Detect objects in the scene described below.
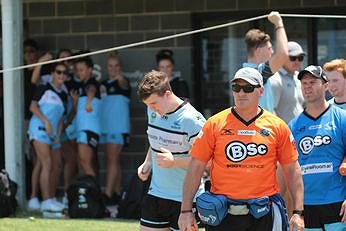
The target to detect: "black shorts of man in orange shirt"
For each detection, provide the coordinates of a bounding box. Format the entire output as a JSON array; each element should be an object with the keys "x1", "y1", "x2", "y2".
[{"x1": 205, "y1": 209, "x2": 273, "y2": 231}]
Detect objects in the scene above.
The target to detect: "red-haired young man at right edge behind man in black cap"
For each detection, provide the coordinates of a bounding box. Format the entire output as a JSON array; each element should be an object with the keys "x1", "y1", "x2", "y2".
[{"x1": 323, "y1": 59, "x2": 346, "y2": 110}]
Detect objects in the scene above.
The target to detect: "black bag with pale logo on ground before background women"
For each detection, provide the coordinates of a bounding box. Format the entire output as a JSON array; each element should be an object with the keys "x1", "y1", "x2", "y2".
[{"x1": 67, "y1": 175, "x2": 107, "y2": 218}]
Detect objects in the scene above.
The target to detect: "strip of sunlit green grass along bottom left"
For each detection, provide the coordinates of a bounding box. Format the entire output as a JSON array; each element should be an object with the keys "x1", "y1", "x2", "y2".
[{"x1": 0, "y1": 211, "x2": 139, "y2": 231}]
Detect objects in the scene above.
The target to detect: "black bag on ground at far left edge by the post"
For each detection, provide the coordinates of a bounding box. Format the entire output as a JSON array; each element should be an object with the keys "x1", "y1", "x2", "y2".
[{"x1": 0, "y1": 169, "x2": 17, "y2": 217}]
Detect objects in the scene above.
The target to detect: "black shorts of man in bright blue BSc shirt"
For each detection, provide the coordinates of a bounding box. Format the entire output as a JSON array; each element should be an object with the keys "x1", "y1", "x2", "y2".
[{"x1": 304, "y1": 202, "x2": 342, "y2": 228}]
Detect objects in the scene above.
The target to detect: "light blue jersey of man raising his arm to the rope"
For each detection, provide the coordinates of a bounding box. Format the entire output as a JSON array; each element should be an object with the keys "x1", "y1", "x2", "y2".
[{"x1": 243, "y1": 62, "x2": 274, "y2": 113}]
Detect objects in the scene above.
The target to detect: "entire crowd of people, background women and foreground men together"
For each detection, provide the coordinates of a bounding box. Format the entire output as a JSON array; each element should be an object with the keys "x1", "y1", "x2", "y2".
[{"x1": 0, "y1": 9, "x2": 346, "y2": 231}]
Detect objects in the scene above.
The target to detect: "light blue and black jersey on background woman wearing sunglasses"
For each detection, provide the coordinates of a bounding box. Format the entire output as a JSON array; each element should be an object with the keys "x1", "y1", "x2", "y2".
[{"x1": 28, "y1": 82, "x2": 67, "y2": 137}]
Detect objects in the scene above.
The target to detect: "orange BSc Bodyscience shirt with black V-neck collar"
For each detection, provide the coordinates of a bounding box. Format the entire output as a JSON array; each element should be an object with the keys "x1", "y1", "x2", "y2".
[{"x1": 190, "y1": 108, "x2": 298, "y2": 199}]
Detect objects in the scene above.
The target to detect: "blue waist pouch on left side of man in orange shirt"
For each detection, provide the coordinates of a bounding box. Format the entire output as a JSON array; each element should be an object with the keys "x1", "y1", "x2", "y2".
[{"x1": 196, "y1": 191, "x2": 228, "y2": 226}]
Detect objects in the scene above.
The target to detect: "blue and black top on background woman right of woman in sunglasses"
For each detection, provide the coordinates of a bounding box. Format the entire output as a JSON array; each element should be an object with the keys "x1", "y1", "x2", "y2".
[{"x1": 76, "y1": 78, "x2": 101, "y2": 135}]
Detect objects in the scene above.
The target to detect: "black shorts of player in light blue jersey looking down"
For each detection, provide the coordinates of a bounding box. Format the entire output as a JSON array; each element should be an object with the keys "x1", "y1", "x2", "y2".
[{"x1": 140, "y1": 194, "x2": 199, "y2": 230}]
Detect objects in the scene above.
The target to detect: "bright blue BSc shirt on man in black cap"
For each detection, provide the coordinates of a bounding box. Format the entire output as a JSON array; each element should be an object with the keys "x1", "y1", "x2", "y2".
[{"x1": 289, "y1": 105, "x2": 346, "y2": 205}]
